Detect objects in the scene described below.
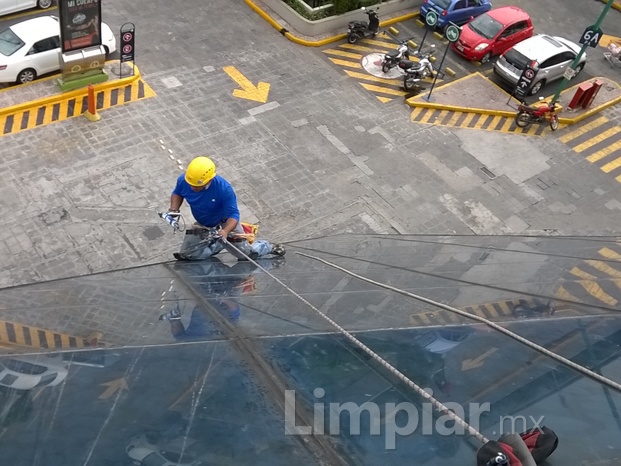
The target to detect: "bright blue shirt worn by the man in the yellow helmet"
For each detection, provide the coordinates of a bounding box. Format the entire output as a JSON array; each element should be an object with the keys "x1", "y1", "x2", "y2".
[{"x1": 172, "y1": 175, "x2": 239, "y2": 227}]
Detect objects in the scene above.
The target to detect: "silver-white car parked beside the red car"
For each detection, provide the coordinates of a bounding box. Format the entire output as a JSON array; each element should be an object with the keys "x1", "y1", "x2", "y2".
[{"x1": 494, "y1": 34, "x2": 586, "y2": 95}]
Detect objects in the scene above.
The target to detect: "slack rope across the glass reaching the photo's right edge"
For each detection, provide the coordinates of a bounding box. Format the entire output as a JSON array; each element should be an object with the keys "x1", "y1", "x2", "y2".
[{"x1": 294, "y1": 251, "x2": 621, "y2": 392}]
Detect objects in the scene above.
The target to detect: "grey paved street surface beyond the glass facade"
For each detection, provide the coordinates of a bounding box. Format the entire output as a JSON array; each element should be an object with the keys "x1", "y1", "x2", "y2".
[{"x1": 0, "y1": 0, "x2": 621, "y2": 292}]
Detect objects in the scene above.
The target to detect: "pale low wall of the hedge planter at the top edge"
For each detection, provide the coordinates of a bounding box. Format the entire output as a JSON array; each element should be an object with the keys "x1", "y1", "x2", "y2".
[{"x1": 263, "y1": 0, "x2": 423, "y2": 36}]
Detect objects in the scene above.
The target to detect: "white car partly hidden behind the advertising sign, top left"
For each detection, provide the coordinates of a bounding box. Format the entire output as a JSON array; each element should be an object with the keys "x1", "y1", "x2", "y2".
[{"x1": 0, "y1": 16, "x2": 116, "y2": 84}]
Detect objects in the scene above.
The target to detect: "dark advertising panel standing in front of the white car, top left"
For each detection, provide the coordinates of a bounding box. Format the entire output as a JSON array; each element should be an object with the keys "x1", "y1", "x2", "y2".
[{"x1": 58, "y1": 0, "x2": 101, "y2": 53}]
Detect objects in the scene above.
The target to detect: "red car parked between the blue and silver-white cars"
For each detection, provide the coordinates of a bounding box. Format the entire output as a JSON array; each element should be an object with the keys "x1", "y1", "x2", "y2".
[{"x1": 451, "y1": 6, "x2": 534, "y2": 63}]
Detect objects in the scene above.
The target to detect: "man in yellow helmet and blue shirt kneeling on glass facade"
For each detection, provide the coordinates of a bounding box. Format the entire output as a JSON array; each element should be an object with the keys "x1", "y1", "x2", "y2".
[{"x1": 168, "y1": 157, "x2": 285, "y2": 260}]
